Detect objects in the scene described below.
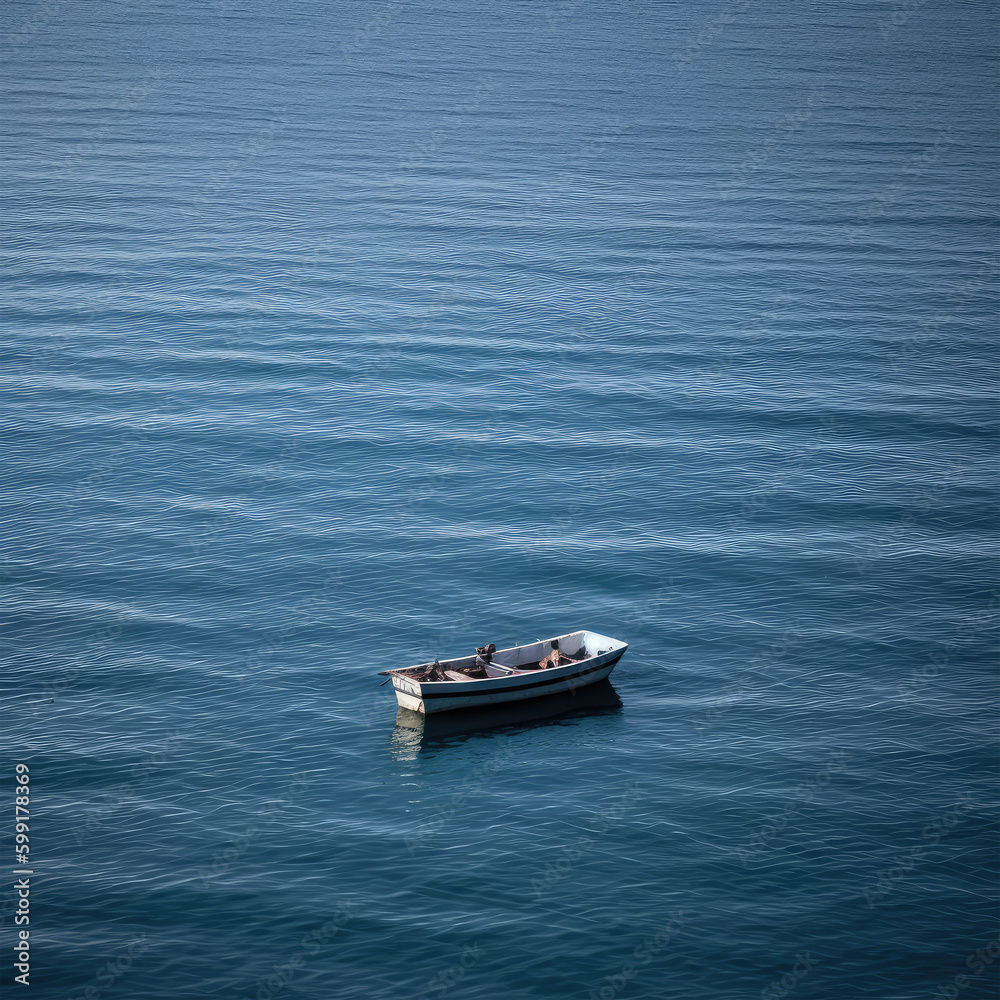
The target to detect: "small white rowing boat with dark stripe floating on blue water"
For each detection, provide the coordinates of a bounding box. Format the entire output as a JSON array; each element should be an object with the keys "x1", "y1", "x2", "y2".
[{"x1": 381, "y1": 631, "x2": 628, "y2": 715}]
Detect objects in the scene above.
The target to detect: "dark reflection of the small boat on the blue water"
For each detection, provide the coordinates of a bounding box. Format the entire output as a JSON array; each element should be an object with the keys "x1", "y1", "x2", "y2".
[{"x1": 392, "y1": 681, "x2": 622, "y2": 757}]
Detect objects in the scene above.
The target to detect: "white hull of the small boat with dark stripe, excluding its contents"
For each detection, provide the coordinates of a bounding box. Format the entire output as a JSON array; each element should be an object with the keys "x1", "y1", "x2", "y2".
[{"x1": 391, "y1": 631, "x2": 628, "y2": 715}]
